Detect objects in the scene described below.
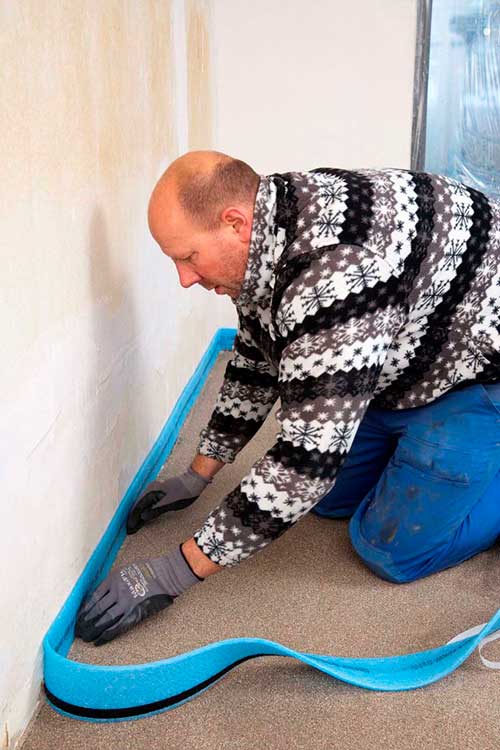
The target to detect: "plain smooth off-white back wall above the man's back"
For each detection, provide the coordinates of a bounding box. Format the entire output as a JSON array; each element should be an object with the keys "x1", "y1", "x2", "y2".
[{"x1": 209, "y1": 0, "x2": 417, "y2": 173}]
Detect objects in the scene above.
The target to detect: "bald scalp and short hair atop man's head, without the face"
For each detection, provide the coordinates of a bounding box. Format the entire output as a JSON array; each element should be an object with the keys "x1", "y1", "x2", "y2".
[{"x1": 149, "y1": 151, "x2": 260, "y2": 231}]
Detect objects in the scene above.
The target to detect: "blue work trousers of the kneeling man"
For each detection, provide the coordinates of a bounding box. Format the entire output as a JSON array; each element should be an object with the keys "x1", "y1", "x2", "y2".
[{"x1": 311, "y1": 384, "x2": 500, "y2": 583}]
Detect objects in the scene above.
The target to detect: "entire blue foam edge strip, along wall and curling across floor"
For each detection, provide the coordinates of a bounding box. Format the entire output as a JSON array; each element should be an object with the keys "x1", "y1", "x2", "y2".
[{"x1": 43, "y1": 329, "x2": 500, "y2": 722}]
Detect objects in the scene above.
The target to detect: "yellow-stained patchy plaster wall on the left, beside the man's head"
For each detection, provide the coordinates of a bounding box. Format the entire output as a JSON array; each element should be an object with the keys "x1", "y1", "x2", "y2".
[{"x1": 0, "y1": 0, "x2": 235, "y2": 747}]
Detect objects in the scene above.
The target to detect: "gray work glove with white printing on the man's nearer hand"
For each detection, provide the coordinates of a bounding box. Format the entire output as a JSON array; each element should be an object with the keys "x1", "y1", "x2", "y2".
[{"x1": 75, "y1": 544, "x2": 205, "y2": 646}]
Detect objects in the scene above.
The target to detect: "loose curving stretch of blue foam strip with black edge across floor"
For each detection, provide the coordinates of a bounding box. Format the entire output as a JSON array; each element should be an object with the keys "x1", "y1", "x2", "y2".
[{"x1": 44, "y1": 610, "x2": 500, "y2": 721}]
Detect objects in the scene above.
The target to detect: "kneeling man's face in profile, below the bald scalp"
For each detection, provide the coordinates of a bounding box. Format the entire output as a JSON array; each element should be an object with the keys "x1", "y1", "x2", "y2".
[{"x1": 148, "y1": 187, "x2": 252, "y2": 299}]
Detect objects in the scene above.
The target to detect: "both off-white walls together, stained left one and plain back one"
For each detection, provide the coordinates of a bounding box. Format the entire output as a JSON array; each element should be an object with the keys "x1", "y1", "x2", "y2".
[{"x1": 0, "y1": 0, "x2": 416, "y2": 747}]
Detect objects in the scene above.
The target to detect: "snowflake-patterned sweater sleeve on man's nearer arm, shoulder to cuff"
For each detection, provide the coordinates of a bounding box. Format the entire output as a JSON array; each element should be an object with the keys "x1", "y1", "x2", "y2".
[{"x1": 194, "y1": 245, "x2": 402, "y2": 566}]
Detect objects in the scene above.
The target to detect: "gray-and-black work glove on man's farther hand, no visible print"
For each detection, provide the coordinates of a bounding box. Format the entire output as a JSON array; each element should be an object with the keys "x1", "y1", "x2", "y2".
[{"x1": 127, "y1": 468, "x2": 212, "y2": 534}]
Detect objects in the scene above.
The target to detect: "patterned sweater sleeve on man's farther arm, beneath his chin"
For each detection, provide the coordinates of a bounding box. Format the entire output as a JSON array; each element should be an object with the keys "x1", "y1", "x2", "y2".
[{"x1": 198, "y1": 317, "x2": 278, "y2": 463}]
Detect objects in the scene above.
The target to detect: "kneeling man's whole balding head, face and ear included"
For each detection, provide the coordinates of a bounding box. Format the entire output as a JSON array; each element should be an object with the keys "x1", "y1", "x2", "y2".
[{"x1": 148, "y1": 151, "x2": 260, "y2": 299}]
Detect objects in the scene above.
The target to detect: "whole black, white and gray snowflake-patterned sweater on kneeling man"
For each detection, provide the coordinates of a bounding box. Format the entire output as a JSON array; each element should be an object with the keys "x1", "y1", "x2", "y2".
[{"x1": 194, "y1": 168, "x2": 500, "y2": 566}]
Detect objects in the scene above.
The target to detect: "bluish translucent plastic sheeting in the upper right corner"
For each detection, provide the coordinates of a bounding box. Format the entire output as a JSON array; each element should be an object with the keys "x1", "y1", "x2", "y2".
[{"x1": 425, "y1": 0, "x2": 500, "y2": 199}]
